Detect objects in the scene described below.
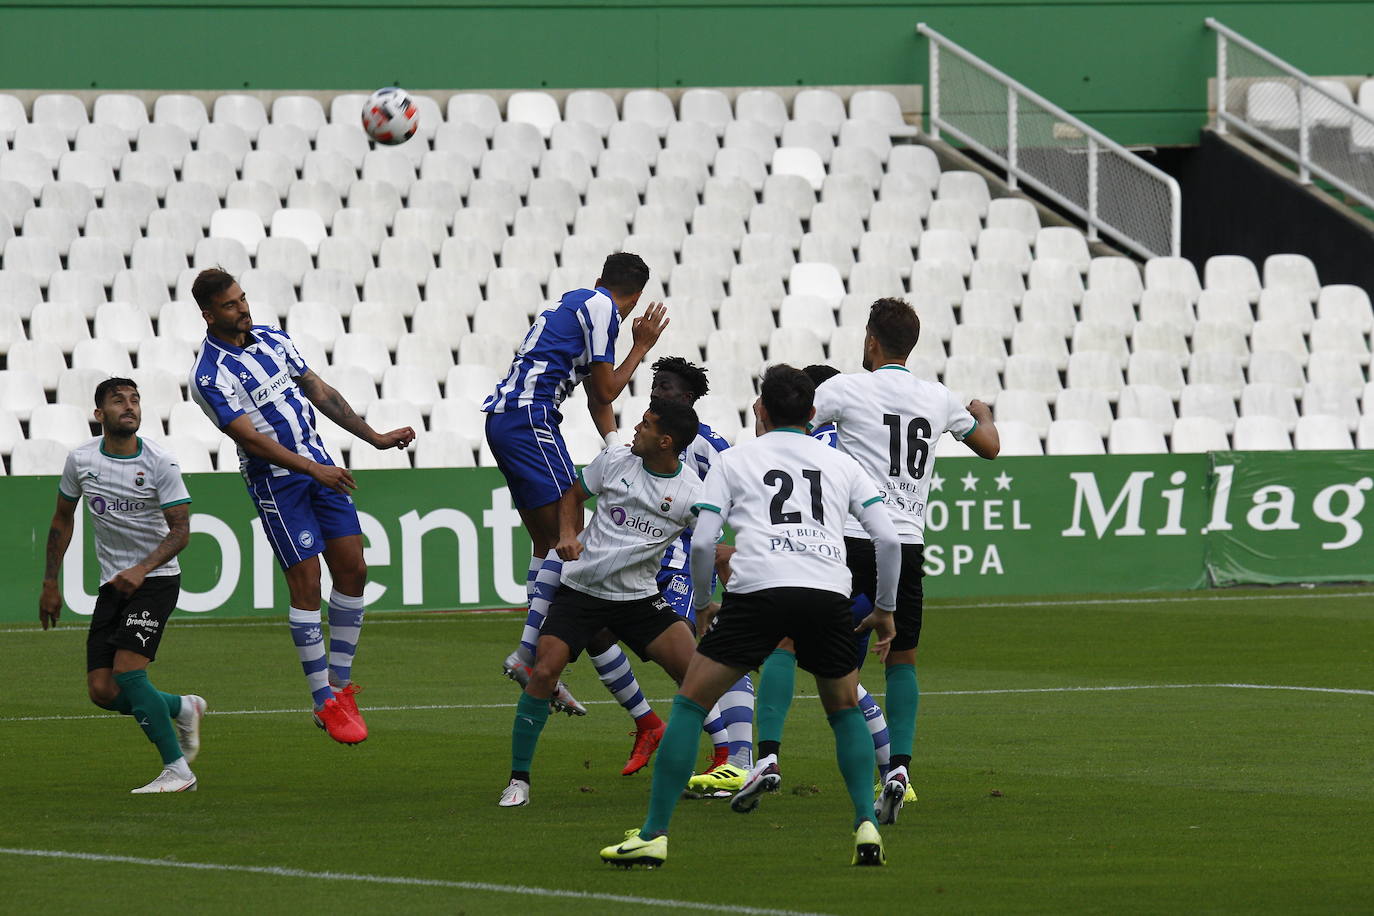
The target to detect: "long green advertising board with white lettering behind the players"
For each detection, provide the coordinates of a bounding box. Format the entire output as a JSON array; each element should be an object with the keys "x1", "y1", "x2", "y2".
[{"x1": 0, "y1": 450, "x2": 1374, "y2": 621}]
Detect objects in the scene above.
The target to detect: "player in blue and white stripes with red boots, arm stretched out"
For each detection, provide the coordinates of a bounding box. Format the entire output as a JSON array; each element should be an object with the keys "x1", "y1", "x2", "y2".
[{"x1": 190, "y1": 268, "x2": 415, "y2": 744}]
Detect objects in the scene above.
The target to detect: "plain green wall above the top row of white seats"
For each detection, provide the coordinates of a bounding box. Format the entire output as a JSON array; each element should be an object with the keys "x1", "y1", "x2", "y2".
[{"x1": 0, "y1": 0, "x2": 1374, "y2": 144}]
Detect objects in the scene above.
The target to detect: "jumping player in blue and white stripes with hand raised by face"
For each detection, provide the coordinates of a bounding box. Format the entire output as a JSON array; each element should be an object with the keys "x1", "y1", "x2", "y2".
[{"x1": 482, "y1": 251, "x2": 668, "y2": 715}]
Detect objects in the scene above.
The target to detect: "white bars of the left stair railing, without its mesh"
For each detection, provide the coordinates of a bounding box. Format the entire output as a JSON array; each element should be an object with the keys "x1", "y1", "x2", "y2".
[{"x1": 916, "y1": 22, "x2": 1183, "y2": 258}]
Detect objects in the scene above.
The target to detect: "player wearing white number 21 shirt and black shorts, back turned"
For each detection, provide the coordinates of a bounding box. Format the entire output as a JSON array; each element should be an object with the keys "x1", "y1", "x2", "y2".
[{"x1": 600, "y1": 365, "x2": 901, "y2": 867}]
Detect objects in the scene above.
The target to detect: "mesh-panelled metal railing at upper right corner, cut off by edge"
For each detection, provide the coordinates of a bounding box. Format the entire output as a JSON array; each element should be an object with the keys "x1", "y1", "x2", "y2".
[{"x1": 1204, "y1": 16, "x2": 1374, "y2": 207}]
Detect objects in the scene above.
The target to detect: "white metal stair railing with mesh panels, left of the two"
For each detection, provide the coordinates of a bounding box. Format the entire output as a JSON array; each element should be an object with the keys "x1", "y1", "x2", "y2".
[{"x1": 916, "y1": 22, "x2": 1183, "y2": 258}]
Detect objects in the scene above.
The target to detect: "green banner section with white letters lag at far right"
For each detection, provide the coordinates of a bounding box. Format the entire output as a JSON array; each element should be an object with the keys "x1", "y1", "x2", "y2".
[{"x1": 1206, "y1": 450, "x2": 1374, "y2": 585}]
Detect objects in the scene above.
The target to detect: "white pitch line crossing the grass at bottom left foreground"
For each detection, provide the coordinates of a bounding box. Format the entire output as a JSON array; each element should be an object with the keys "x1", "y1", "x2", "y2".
[{"x1": 0, "y1": 846, "x2": 822, "y2": 916}]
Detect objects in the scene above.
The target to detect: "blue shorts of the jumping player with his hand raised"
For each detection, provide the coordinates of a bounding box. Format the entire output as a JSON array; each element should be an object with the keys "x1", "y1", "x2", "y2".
[{"x1": 486, "y1": 404, "x2": 577, "y2": 509}]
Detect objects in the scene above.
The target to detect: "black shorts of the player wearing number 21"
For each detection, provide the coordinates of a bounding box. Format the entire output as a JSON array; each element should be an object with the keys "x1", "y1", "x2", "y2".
[{"x1": 697, "y1": 588, "x2": 856, "y2": 677}]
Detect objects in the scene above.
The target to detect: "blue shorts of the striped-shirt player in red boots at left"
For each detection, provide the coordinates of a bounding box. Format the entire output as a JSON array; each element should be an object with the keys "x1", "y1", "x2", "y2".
[{"x1": 249, "y1": 474, "x2": 363, "y2": 570}]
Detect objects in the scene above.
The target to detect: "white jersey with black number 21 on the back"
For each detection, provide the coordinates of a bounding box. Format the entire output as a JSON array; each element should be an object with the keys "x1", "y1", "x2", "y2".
[{"x1": 697, "y1": 428, "x2": 882, "y2": 596}]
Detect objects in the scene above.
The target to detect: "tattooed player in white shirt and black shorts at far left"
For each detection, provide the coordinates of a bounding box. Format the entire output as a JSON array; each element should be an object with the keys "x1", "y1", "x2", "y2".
[{"x1": 38, "y1": 378, "x2": 205, "y2": 795}]
